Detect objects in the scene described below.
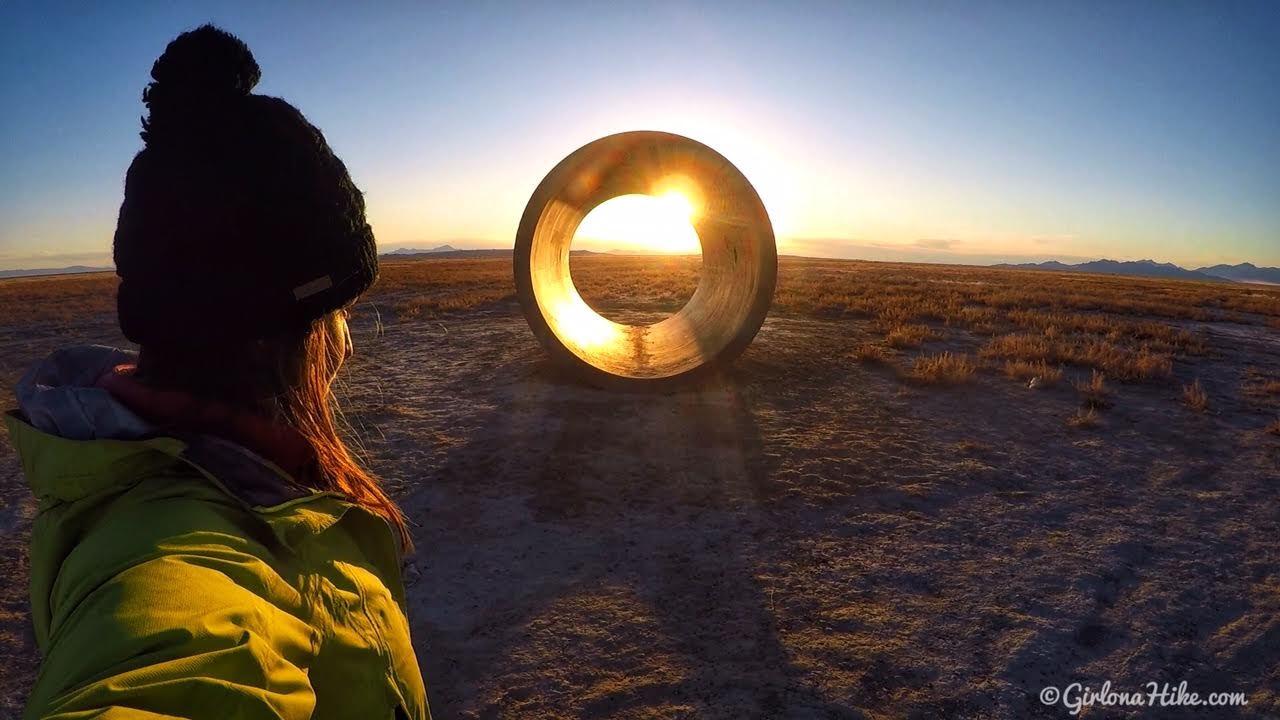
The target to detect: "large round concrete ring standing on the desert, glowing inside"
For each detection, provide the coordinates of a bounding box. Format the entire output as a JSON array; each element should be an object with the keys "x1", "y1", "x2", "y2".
[{"x1": 515, "y1": 131, "x2": 778, "y2": 389}]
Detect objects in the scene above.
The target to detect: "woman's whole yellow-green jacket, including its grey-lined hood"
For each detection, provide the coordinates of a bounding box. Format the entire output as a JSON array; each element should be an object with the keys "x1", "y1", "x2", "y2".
[{"x1": 5, "y1": 346, "x2": 430, "y2": 719}]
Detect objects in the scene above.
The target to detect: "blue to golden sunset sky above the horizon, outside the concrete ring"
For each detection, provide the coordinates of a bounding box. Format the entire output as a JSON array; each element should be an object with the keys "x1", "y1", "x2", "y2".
[{"x1": 0, "y1": 0, "x2": 1280, "y2": 269}]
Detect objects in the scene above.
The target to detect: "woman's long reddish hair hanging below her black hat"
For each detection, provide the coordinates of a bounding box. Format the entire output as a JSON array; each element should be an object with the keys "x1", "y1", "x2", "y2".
[{"x1": 138, "y1": 305, "x2": 412, "y2": 551}]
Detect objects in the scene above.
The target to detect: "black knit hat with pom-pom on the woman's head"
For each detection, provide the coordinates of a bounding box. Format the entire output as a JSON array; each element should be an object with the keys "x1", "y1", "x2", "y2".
[{"x1": 114, "y1": 26, "x2": 378, "y2": 346}]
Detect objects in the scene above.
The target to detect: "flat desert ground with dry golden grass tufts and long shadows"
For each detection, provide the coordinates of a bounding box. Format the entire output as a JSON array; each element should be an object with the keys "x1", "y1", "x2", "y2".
[{"x1": 0, "y1": 256, "x2": 1280, "y2": 719}]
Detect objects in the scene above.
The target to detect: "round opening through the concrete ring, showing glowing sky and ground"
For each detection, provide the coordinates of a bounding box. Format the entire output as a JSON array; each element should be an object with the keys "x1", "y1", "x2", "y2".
[{"x1": 570, "y1": 192, "x2": 703, "y2": 325}]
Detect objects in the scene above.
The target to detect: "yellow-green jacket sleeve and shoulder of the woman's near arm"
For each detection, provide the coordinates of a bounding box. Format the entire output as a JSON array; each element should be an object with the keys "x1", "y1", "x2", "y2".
[{"x1": 28, "y1": 478, "x2": 316, "y2": 717}]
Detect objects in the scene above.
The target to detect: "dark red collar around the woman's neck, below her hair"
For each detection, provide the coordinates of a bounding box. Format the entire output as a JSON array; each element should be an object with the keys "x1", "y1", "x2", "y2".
[{"x1": 95, "y1": 364, "x2": 316, "y2": 484}]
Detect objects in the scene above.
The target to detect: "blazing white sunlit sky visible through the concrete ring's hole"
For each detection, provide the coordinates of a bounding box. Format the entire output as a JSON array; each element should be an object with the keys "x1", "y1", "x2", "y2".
[{"x1": 573, "y1": 190, "x2": 701, "y2": 255}]
